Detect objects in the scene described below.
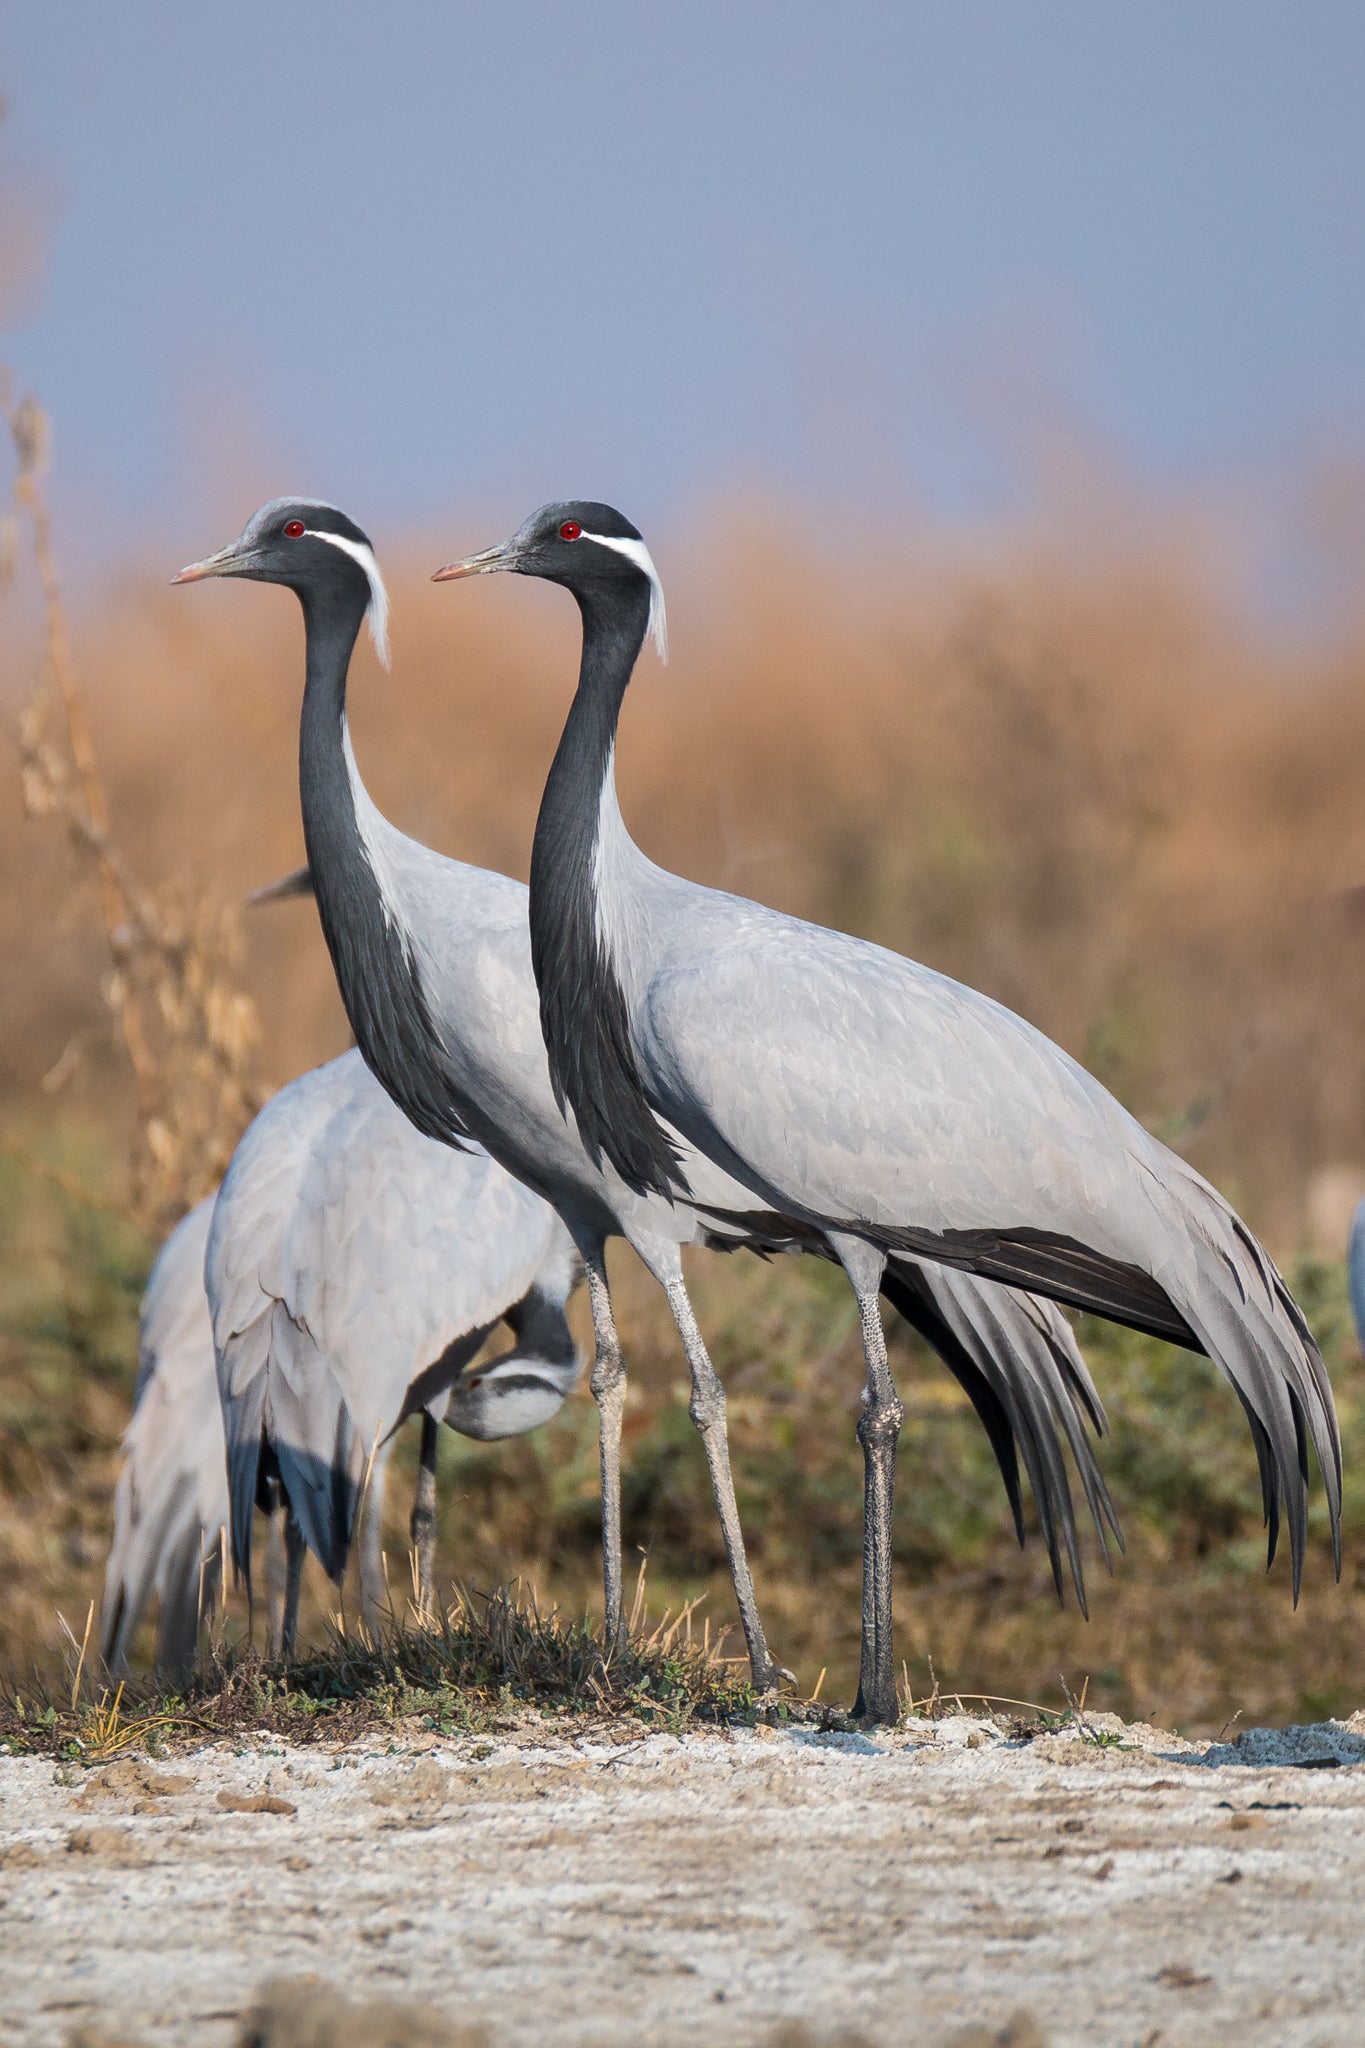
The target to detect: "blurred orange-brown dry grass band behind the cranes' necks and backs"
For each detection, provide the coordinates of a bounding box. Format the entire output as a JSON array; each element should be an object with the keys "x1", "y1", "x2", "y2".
[{"x1": 0, "y1": 471, "x2": 1365, "y2": 1249}]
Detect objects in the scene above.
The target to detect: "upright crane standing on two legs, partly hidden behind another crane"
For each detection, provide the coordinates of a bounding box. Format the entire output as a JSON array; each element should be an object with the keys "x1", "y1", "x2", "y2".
[{"x1": 176, "y1": 498, "x2": 1117, "y2": 1690}]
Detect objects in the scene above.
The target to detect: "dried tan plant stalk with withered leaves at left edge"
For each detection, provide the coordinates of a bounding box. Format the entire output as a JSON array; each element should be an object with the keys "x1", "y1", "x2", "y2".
[{"x1": 0, "y1": 377, "x2": 264, "y2": 1231}]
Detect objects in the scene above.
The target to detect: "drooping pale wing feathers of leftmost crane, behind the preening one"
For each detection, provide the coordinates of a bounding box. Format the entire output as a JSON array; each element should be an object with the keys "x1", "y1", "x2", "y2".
[{"x1": 100, "y1": 1196, "x2": 227, "y2": 1669}]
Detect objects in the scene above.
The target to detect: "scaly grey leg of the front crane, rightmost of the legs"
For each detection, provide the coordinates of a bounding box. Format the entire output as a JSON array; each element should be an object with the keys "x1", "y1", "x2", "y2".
[{"x1": 835, "y1": 1239, "x2": 905, "y2": 1729}]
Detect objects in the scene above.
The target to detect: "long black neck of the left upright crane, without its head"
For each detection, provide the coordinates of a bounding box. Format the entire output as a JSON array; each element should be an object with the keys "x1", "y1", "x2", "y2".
[{"x1": 299, "y1": 592, "x2": 469, "y2": 1145}]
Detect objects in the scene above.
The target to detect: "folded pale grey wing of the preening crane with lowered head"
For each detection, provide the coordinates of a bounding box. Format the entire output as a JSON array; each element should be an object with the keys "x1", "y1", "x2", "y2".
[{"x1": 207, "y1": 1053, "x2": 559, "y2": 1575}]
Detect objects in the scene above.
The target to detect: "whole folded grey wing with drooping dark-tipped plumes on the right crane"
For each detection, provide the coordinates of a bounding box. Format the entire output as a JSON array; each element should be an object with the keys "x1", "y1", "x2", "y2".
[{"x1": 632, "y1": 885, "x2": 1340, "y2": 1589}]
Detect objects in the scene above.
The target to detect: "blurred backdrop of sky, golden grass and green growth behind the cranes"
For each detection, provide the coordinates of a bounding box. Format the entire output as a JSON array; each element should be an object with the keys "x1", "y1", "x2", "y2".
[{"x1": 0, "y1": 0, "x2": 1365, "y2": 1726}]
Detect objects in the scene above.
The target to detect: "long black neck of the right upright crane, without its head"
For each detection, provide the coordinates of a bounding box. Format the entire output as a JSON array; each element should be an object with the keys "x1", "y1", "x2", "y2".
[{"x1": 530, "y1": 578, "x2": 688, "y2": 1198}]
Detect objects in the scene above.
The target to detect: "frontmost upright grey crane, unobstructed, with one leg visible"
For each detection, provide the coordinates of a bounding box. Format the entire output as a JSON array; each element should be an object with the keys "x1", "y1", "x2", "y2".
[{"x1": 436, "y1": 502, "x2": 1340, "y2": 1720}]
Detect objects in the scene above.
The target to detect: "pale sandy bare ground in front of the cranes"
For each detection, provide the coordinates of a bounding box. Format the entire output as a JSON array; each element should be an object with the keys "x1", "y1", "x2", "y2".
[{"x1": 0, "y1": 1716, "x2": 1365, "y2": 2048}]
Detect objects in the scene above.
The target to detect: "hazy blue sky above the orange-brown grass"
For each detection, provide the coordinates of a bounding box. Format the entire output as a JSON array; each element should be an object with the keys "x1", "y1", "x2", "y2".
[{"x1": 0, "y1": 0, "x2": 1365, "y2": 593}]
